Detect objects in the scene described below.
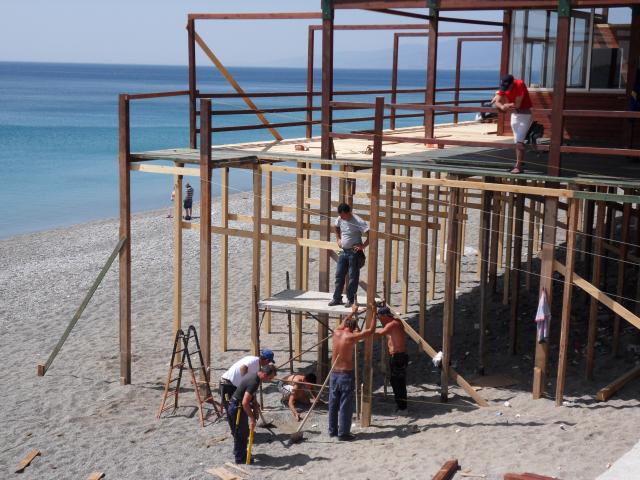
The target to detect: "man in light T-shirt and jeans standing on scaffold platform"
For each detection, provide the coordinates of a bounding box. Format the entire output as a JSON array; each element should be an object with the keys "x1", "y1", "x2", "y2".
[{"x1": 329, "y1": 203, "x2": 369, "y2": 308}]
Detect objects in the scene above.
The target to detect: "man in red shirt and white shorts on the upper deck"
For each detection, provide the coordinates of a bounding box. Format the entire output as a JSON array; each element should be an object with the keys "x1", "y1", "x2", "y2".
[{"x1": 494, "y1": 74, "x2": 532, "y2": 173}]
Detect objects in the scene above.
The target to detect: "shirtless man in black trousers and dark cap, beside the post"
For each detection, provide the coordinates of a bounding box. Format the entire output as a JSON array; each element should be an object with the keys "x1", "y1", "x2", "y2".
[{"x1": 376, "y1": 306, "x2": 409, "y2": 413}]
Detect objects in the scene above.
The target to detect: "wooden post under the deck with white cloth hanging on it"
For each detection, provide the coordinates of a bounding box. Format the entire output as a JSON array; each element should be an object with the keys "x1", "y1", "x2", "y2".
[{"x1": 533, "y1": 197, "x2": 558, "y2": 399}]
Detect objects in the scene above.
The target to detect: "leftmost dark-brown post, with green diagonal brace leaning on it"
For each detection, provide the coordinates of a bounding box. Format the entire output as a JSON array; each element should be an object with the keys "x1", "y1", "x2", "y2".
[{"x1": 118, "y1": 95, "x2": 131, "y2": 385}]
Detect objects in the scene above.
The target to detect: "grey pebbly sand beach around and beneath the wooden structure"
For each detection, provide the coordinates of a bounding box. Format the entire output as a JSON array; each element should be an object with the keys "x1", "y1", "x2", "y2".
[{"x1": 0, "y1": 181, "x2": 640, "y2": 480}]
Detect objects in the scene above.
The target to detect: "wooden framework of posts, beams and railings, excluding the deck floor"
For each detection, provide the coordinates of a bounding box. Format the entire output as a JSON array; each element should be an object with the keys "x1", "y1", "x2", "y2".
[{"x1": 119, "y1": 0, "x2": 640, "y2": 432}]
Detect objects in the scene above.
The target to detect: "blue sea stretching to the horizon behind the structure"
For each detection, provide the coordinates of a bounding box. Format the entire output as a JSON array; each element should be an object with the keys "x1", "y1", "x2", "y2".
[{"x1": 0, "y1": 62, "x2": 499, "y2": 238}]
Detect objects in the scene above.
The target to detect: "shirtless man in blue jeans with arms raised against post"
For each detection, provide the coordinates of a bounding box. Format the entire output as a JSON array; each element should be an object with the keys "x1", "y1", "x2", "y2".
[{"x1": 329, "y1": 305, "x2": 376, "y2": 440}]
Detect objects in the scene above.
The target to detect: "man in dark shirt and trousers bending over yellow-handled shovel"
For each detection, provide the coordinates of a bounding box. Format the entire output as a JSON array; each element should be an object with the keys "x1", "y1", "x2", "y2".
[{"x1": 227, "y1": 365, "x2": 277, "y2": 463}]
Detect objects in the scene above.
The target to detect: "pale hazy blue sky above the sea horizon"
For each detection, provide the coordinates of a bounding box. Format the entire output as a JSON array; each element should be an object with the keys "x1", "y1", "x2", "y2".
[{"x1": 0, "y1": 0, "x2": 501, "y2": 68}]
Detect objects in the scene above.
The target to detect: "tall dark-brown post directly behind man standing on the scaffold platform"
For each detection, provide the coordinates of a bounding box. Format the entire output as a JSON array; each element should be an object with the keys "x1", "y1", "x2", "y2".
[{"x1": 317, "y1": 0, "x2": 334, "y2": 380}]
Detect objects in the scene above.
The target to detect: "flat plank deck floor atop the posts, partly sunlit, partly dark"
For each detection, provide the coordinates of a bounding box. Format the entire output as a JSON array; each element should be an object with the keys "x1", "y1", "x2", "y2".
[{"x1": 131, "y1": 122, "x2": 640, "y2": 188}]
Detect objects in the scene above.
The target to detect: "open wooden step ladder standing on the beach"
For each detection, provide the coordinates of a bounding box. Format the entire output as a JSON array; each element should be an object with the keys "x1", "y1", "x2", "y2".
[{"x1": 156, "y1": 325, "x2": 222, "y2": 427}]
